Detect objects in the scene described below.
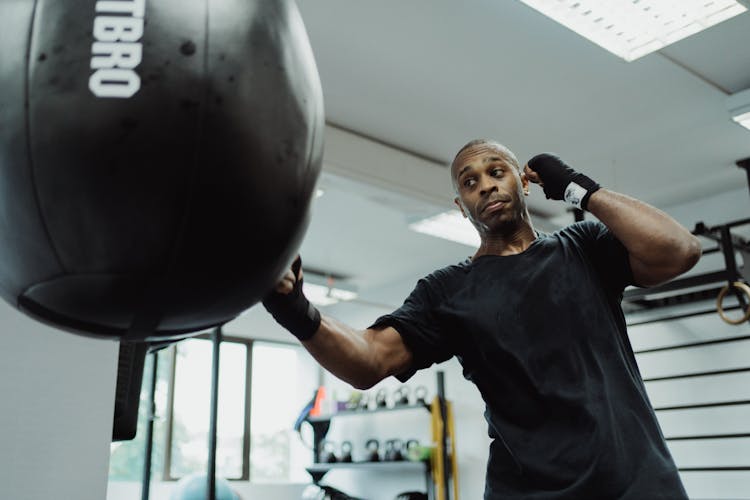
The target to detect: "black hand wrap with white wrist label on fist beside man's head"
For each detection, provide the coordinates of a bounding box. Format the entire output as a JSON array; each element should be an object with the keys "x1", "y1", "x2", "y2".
[{"x1": 527, "y1": 153, "x2": 601, "y2": 210}]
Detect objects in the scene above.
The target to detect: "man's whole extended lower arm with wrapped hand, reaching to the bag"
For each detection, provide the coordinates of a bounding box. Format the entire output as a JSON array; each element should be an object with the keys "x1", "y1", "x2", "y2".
[{"x1": 263, "y1": 258, "x2": 412, "y2": 389}]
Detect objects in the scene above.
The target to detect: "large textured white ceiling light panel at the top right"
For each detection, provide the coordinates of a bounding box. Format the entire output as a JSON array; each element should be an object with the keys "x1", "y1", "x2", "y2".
[{"x1": 521, "y1": 0, "x2": 747, "y2": 61}]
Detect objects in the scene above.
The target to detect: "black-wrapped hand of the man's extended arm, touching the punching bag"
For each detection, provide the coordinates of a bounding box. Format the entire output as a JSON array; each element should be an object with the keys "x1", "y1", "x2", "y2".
[{"x1": 263, "y1": 257, "x2": 320, "y2": 340}]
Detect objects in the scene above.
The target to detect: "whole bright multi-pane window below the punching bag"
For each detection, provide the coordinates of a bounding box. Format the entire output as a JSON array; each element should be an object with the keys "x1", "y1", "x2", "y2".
[{"x1": 109, "y1": 335, "x2": 320, "y2": 490}]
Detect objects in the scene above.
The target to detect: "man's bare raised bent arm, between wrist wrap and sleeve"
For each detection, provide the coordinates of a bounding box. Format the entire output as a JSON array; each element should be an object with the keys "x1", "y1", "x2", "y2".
[{"x1": 586, "y1": 188, "x2": 701, "y2": 286}]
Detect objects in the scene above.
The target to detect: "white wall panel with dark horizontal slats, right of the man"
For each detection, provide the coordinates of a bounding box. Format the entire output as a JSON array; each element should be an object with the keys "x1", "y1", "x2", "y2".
[{"x1": 628, "y1": 304, "x2": 750, "y2": 500}]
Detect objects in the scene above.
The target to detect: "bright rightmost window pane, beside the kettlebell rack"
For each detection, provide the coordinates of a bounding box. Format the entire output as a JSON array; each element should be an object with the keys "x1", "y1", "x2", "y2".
[{"x1": 250, "y1": 342, "x2": 319, "y2": 482}]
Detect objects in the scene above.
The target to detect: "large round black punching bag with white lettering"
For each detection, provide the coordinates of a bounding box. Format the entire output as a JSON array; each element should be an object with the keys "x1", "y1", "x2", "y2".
[{"x1": 0, "y1": 0, "x2": 324, "y2": 340}]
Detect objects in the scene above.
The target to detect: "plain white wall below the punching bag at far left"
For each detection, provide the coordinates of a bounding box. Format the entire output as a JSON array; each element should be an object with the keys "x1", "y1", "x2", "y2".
[{"x1": 0, "y1": 301, "x2": 118, "y2": 500}]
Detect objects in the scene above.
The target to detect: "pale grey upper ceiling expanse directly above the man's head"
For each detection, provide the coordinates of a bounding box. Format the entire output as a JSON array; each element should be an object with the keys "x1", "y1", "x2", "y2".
[{"x1": 299, "y1": 0, "x2": 750, "y2": 203}]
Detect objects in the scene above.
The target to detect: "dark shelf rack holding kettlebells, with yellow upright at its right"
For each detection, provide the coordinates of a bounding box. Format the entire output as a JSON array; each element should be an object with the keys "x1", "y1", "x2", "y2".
[{"x1": 306, "y1": 372, "x2": 458, "y2": 500}]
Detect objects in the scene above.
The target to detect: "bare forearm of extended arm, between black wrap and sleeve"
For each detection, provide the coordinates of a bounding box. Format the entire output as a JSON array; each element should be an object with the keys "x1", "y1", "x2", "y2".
[{"x1": 302, "y1": 315, "x2": 388, "y2": 389}]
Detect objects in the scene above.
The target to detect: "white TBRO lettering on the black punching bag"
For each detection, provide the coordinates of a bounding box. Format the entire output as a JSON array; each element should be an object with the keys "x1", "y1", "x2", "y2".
[{"x1": 89, "y1": 0, "x2": 146, "y2": 99}]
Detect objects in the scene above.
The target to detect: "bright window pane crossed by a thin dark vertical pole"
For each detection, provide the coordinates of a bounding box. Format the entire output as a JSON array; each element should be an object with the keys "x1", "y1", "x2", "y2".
[{"x1": 170, "y1": 339, "x2": 247, "y2": 479}]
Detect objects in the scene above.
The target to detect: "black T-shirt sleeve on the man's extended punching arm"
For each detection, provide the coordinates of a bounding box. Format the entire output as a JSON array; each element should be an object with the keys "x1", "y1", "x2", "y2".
[{"x1": 370, "y1": 275, "x2": 453, "y2": 382}]
